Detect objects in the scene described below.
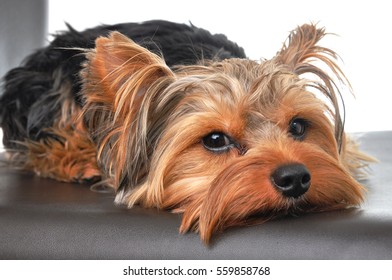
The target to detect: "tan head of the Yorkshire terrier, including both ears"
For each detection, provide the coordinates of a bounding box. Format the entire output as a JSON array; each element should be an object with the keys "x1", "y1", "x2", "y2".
[{"x1": 82, "y1": 25, "x2": 363, "y2": 242}]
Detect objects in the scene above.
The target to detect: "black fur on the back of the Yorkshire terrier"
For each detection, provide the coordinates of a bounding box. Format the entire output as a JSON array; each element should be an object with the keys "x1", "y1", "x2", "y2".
[{"x1": 0, "y1": 20, "x2": 245, "y2": 148}]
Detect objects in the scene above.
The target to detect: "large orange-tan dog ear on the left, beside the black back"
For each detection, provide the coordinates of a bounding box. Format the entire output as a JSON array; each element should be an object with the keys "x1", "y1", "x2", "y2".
[{"x1": 81, "y1": 32, "x2": 174, "y2": 190}]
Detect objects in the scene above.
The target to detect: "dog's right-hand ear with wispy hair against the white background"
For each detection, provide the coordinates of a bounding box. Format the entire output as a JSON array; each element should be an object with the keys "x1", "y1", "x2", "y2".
[{"x1": 275, "y1": 24, "x2": 351, "y2": 147}]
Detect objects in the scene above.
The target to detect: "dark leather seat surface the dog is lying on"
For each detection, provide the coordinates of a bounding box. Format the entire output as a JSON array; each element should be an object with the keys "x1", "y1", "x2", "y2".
[{"x1": 0, "y1": 131, "x2": 392, "y2": 259}]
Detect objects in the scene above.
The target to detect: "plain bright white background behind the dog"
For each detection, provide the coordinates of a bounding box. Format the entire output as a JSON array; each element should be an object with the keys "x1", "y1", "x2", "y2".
[{"x1": 40, "y1": 0, "x2": 392, "y2": 132}]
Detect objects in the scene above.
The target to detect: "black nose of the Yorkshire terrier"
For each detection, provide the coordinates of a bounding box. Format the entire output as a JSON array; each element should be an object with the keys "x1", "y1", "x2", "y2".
[{"x1": 271, "y1": 163, "x2": 310, "y2": 198}]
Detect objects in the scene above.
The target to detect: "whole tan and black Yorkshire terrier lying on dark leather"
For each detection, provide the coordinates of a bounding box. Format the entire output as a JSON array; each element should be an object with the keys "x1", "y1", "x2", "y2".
[{"x1": 0, "y1": 21, "x2": 371, "y2": 243}]
